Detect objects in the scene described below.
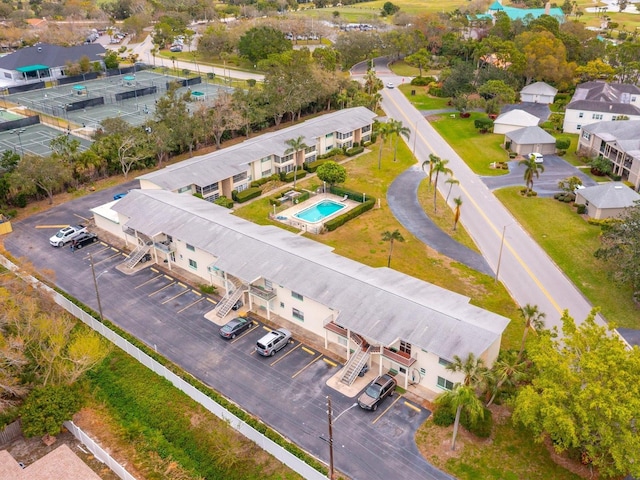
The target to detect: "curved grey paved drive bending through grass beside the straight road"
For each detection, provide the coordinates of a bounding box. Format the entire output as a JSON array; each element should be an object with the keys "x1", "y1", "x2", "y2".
[{"x1": 387, "y1": 165, "x2": 493, "y2": 275}]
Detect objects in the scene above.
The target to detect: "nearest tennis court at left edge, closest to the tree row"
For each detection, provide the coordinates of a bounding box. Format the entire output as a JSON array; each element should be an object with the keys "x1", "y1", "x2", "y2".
[{"x1": 0, "y1": 124, "x2": 91, "y2": 156}]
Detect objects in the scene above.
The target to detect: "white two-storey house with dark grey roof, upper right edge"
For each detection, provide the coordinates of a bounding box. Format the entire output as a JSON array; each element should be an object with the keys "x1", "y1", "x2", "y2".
[{"x1": 562, "y1": 81, "x2": 640, "y2": 133}]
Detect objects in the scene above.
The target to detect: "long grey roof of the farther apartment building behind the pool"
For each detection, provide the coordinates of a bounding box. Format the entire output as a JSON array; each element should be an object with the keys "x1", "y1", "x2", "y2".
[{"x1": 138, "y1": 107, "x2": 376, "y2": 190}]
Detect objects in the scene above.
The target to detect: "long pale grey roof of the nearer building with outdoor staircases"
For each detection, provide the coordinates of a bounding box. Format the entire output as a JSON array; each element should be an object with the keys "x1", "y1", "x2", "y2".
[{"x1": 112, "y1": 190, "x2": 509, "y2": 359}]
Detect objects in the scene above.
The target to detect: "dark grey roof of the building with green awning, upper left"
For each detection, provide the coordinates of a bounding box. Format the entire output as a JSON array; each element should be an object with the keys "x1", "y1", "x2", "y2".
[{"x1": 0, "y1": 43, "x2": 105, "y2": 70}]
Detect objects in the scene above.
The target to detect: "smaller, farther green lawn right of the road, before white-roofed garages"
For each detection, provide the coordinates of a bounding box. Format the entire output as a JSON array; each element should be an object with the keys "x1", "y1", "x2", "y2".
[{"x1": 428, "y1": 113, "x2": 509, "y2": 175}]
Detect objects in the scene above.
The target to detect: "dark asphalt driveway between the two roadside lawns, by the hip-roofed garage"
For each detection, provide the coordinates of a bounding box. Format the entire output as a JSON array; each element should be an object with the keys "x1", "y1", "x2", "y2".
[{"x1": 480, "y1": 155, "x2": 597, "y2": 197}]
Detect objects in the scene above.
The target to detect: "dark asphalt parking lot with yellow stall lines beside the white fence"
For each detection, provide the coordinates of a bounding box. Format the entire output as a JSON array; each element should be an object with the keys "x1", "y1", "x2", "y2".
[{"x1": 5, "y1": 186, "x2": 450, "y2": 479}]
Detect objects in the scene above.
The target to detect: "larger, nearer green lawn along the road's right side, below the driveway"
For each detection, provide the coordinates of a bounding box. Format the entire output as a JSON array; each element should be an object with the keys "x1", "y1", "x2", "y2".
[{"x1": 495, "y1": 189, "x2": 640, "y2": 328}]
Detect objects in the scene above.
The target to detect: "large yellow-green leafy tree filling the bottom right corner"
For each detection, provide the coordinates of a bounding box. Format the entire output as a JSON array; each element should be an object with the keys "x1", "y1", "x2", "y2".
[{"x1": 513, "y1": 311, "x2": 640, "y2": 478}]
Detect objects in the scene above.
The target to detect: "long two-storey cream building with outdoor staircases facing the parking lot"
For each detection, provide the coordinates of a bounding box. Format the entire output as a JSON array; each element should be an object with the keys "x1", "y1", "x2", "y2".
[{"x1": 93, "y1": 189, "x2": 509, "y2": 392}]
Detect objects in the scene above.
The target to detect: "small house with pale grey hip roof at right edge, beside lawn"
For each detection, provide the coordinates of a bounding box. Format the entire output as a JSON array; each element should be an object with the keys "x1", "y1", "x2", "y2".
[{"x1": 575, "y1": 182, "x2": 640, "y2": 219}]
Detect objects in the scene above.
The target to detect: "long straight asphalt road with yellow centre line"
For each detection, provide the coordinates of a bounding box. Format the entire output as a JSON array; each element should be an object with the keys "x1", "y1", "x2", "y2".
[{"x1": 376, "y1": 79, "x2": 604, "y2": 334}]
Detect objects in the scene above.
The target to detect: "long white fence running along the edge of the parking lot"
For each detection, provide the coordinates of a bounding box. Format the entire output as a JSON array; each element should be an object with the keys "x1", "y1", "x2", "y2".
[{"x1": 0, "y1": 255, "x2": 326, "y2": 480}]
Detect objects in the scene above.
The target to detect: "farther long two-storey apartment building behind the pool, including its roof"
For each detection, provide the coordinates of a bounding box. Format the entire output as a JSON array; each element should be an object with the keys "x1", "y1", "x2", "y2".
[{"x1": 139, "y1": 107, "x2": 376, "y2": 202}]
